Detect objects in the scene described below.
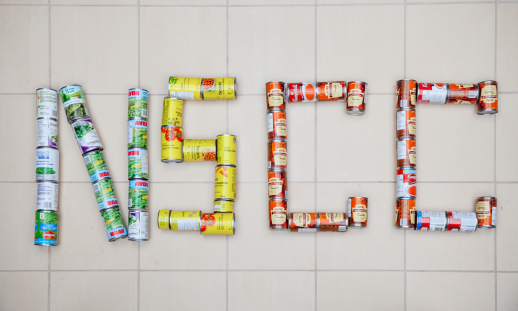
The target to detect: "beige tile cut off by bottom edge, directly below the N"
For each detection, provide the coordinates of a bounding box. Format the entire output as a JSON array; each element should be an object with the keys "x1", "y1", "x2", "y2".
[{"x1": 50, "y1": 271, "x2": 137, "y2": 311}]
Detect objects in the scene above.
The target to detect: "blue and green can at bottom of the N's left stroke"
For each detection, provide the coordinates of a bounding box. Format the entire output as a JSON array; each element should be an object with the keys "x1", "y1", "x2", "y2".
[{"x1": 34, "y1": 210, "x2": 59, "y2": 246}]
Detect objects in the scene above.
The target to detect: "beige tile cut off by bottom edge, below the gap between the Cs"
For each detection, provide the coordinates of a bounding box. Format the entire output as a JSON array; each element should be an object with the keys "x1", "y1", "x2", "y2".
[{"x1": 317, "y1": 271, "x2": 404, "y2": 311}]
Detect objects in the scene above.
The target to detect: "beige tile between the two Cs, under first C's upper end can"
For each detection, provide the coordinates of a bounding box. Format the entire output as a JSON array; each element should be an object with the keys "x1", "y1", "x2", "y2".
[{"x1": 317, "y1": 95, "x2": 396, "y2": 181}]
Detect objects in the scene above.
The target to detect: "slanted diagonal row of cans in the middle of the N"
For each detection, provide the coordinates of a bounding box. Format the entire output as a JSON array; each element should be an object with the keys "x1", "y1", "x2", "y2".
[{"x1": 59, "y1": 85, "x2": 128, "y2": 242}]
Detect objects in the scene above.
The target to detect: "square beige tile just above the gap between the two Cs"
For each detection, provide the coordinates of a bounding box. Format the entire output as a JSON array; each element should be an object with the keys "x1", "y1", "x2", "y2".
[{"x1": 317, "y1": 5, "x2": 404, "y2": 94}]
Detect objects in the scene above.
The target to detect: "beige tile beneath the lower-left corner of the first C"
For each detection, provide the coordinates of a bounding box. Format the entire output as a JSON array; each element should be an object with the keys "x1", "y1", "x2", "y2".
[{"x1": 228, "y1": 183, "x2": 315, "y2": 270}]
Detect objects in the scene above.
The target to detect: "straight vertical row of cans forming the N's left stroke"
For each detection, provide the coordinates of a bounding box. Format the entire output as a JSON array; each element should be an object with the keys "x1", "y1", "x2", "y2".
[{"x1": 34, "y1": 88, "x2": 59, "y2": 246}]
